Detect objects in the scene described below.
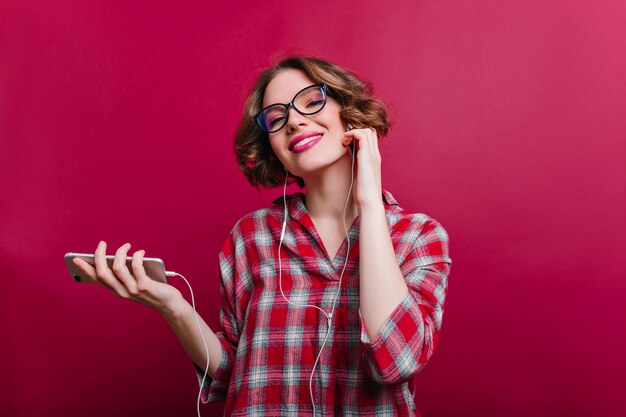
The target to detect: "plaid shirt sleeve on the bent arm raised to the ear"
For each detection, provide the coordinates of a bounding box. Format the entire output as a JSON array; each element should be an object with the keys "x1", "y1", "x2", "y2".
[{"x1": 361, "y1": 215, "x2": 452, "y2": 384}]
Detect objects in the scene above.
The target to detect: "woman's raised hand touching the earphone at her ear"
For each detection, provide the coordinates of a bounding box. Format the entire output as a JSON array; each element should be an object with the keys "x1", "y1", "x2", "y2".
[{"x1": 342, "y1": 128, "x2": 382, "y2": 209}]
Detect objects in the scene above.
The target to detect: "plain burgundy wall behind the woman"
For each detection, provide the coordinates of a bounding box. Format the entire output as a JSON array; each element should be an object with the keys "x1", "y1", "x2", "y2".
[{"x1": 0, "y1": 0, "x2": 626, "y2": 417}]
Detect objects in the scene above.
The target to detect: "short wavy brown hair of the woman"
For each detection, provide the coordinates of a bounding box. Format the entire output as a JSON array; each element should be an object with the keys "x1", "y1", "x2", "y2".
[{"x1": 234, "y1": 56, "x2": 391, "y2": 189}]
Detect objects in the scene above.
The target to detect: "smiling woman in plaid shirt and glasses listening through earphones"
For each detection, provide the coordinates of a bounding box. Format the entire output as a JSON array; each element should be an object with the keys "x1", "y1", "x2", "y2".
[{"x1": 77, "y1": 57, "x2": 451, "y2": 416}]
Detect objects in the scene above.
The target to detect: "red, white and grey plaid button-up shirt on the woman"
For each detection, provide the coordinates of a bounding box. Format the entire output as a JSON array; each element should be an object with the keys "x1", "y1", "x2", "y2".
[{"x1": 196, "y1": 191, "x2": 452, "y2": 416}]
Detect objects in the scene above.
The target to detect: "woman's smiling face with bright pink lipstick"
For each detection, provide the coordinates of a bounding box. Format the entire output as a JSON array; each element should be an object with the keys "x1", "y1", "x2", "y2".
[{"x1": 263, "y1": 69, "x2": 348, "y2": 182}]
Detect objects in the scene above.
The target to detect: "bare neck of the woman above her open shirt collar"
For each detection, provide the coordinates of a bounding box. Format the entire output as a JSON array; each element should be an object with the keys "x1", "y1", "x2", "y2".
[{"x1": 304, "y1": 152, "x2": 358, "y2": 224}]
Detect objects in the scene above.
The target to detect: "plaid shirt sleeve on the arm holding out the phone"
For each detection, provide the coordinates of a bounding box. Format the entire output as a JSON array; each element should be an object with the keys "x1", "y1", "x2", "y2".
[{"x1": 194, "y1": 223, "x2": 251, "y2": 404}]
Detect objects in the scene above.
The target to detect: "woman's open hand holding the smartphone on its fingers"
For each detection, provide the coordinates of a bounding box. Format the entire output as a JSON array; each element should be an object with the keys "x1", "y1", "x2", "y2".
[{"x1": 74, "y1": 242, "x2": 183, "y2": 313}]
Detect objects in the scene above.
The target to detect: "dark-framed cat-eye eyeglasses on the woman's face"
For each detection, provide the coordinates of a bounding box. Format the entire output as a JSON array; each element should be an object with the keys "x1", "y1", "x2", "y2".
[{"x1": 254, "y1": 83, "x2": 328, "y2": 133}]
